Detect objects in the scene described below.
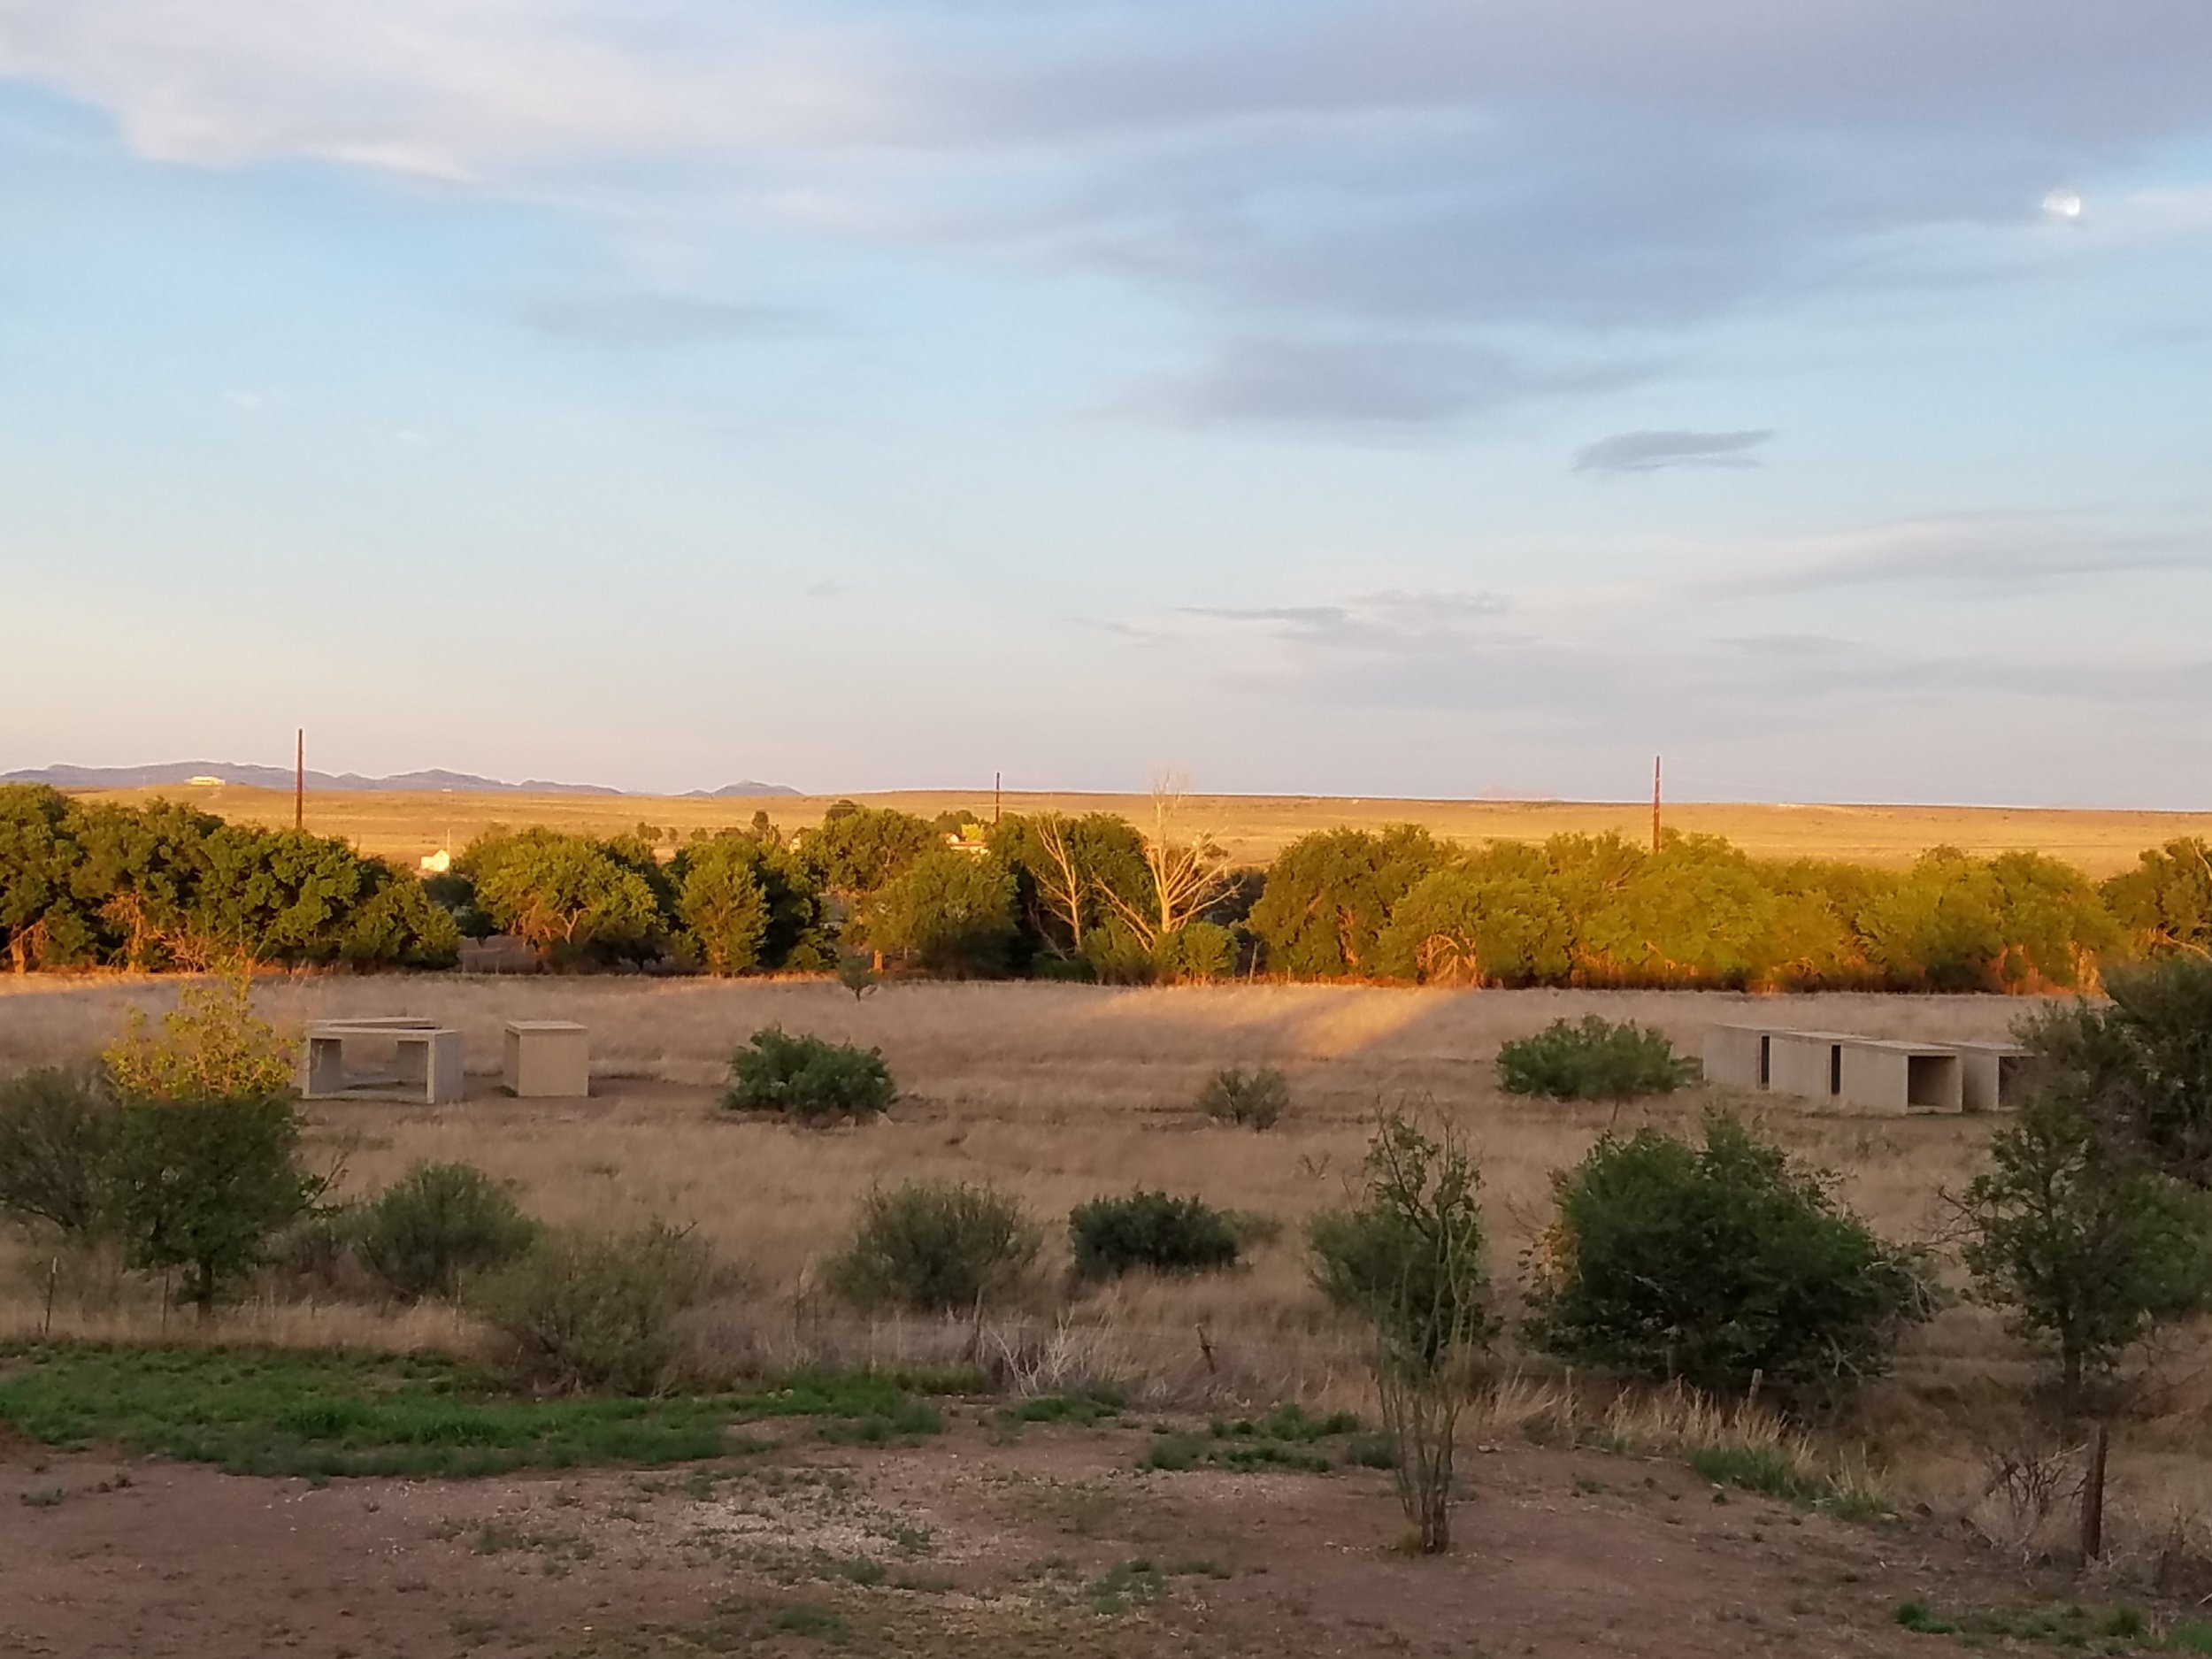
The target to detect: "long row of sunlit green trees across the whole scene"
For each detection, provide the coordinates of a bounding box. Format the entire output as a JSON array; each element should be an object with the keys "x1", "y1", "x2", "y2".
[{"x1": 0, "y1": 786, "x2": 2212, "y2": 991}]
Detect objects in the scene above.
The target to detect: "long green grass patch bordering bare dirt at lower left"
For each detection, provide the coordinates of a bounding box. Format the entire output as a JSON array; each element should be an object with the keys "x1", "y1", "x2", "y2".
[{"x1": 0, "y1": 1343, "x2": 941, "y2": 1478}]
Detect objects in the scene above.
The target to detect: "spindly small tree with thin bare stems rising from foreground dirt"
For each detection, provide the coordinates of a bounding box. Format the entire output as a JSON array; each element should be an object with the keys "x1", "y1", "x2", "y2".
[{"x1": 1308, "y1": 1115, "x2": 1495, "y2": 1555}]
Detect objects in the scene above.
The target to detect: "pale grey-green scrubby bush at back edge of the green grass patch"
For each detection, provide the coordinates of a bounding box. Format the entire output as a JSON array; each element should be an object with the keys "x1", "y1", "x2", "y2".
[{"x1": 473, "y1": 1224, "x2": 715, "y2": 1394}]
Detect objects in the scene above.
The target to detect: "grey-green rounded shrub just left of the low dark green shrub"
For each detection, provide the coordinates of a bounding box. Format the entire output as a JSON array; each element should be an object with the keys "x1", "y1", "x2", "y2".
[{"x1": 830, "y1": 1181, "x2": 1044, "y2": 1314}]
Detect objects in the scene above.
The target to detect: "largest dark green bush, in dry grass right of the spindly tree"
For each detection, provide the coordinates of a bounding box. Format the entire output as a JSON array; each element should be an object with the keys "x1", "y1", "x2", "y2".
[{"x1": 1529, "y1": 1113, "x2": 1929, "y2": 1394}]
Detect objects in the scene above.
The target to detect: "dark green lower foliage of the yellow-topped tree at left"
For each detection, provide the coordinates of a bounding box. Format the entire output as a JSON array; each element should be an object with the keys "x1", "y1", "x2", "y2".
[{"x1": 118, "y1": 1095, "x2": 327, "y2": 1317}]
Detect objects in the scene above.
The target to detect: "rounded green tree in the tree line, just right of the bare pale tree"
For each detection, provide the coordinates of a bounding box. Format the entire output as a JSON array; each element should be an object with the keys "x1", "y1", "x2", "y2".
[{"x1": 1248, "y1": 823, "x2": 1451, "y2": 980}]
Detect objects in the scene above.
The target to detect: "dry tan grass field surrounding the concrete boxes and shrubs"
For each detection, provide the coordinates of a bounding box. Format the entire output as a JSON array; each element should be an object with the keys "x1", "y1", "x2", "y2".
[{"x1": 0, "y1": 976, "x2": 2212, "y2": 1566}]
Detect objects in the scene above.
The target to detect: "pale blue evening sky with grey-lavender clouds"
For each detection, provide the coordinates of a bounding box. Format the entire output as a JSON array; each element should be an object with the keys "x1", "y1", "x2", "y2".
[{"x1": 0, "y1": 0, "x2": 2212, "y2": 810}]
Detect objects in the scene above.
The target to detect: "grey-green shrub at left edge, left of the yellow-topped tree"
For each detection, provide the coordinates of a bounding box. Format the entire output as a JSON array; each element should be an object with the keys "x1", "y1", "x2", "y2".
[{"x1": 0, "y1": 1066, "x2": 122, "y2": 1241}]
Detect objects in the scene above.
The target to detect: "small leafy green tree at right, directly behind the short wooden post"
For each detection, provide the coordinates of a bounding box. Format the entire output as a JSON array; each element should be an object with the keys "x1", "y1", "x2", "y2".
[{"x1": 1960, "y1": 1095, "x2": 2212, "y2": 1411}]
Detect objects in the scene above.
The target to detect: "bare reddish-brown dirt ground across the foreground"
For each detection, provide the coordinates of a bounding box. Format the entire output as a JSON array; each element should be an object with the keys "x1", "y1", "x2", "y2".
[{"x1": 0, "y1": 1407, "x2": 2022, "y2": 1659}]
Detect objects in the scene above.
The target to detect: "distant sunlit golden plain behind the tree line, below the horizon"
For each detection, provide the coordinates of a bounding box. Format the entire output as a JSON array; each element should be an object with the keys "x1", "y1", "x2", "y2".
[{"x1": 65, "y1": 786, "x2": 2212, "y2": 876}]
